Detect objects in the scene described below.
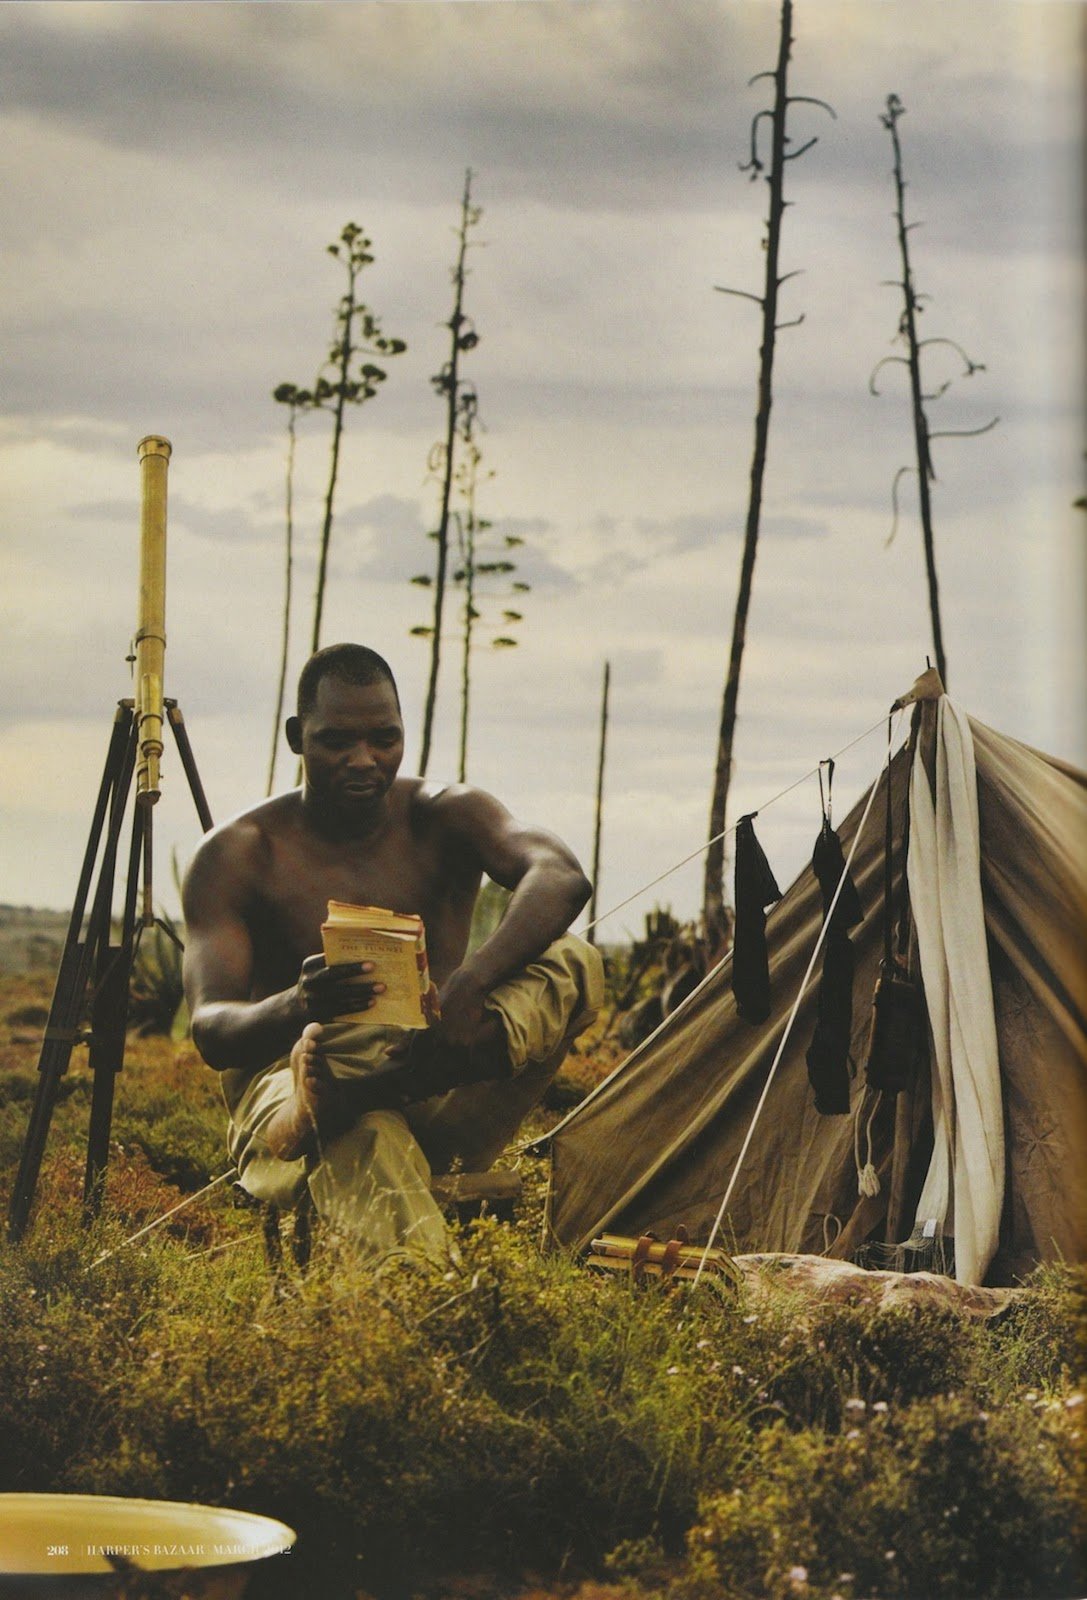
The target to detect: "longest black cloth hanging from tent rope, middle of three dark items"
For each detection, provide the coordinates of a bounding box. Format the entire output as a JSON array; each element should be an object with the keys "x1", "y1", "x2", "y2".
[{"x1": 805, "y1": 816, "x2": 864, "y2": 1117}]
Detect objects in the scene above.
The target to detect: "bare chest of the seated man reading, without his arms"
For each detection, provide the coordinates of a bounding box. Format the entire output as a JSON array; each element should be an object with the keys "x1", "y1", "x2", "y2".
[{"x1": 227, "y1": 778, "x2": 482, "y2": 998}]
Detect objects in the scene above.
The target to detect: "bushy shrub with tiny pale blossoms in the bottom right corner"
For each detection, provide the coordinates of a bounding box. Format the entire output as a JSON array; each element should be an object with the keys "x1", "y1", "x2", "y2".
[{"x1": 674, "y1": 1397, "x2": 1087, "y2": 1600}]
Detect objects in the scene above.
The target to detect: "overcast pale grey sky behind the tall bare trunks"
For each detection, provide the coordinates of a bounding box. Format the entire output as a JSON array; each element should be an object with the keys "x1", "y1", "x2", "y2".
[{"x1": 0, "y1": 0, "x2": 1087, "y2": 938}]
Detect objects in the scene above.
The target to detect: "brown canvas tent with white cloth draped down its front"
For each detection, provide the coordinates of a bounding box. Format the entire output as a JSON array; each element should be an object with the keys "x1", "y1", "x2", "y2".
[{"x1": 548, "y1": 680, "x2": 1087, "y2": 1283}]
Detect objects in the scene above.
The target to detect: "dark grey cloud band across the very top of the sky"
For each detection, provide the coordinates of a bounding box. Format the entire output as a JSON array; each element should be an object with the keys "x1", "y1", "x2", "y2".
[{"x1": 0, "y1": 0, "x2": 1073, "y2": 236}]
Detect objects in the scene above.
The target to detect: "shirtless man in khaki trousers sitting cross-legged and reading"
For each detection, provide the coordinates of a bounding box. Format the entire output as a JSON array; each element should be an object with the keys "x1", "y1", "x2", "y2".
[{"x1": 184, "y1": 645, "x2": 600, "y2": 1248}]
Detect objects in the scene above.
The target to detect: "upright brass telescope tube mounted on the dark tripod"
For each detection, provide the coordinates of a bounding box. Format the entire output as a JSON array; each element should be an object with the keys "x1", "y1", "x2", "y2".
[{"x1": 133, "y1": 434, "x2": 170, "y2": 805}]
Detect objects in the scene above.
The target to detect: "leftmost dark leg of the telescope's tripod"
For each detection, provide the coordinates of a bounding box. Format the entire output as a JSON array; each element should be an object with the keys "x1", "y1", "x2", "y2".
[{"x1": 8, "y1": 701, "x2": 136, "y2": 1240}]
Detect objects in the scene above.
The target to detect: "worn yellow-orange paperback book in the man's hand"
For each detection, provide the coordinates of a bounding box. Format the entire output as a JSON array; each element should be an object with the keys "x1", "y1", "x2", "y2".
[{"x1": 320, "y1": 901, "x2": 434, "y2": 1027}]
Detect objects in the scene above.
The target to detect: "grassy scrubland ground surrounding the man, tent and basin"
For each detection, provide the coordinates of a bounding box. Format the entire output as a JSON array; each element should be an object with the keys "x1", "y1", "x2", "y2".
[{"x1": 0, "y1": 971, "x2": 1087, "y2": 1600}]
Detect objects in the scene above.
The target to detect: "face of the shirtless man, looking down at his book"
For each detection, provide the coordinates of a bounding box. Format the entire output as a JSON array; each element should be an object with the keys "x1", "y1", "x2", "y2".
[{"x1": 287, "y1": 677, "x2": 403, "y2": 818}]
